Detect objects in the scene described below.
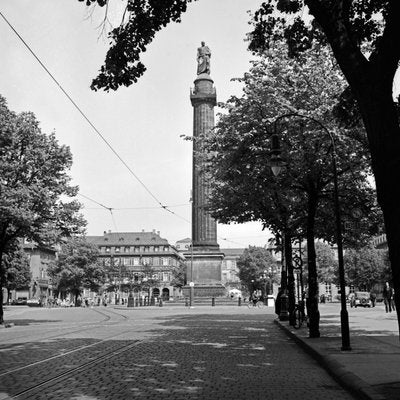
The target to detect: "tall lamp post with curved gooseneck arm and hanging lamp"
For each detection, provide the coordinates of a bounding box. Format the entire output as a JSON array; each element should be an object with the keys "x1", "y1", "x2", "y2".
[{"x1": 270, "y1": 113, "x2": 351, "y2": 350}]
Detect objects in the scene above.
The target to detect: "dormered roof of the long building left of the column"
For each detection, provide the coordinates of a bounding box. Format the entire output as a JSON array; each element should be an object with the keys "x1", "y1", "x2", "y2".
[{"x1": 86, "y1": 231, "x2": 169, "y2": 246}]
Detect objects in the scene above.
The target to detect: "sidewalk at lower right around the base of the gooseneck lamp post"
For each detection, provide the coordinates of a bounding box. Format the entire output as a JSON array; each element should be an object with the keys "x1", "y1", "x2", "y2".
[{"x1": 275, "y1": 304, "x2": 400, "y2": 400}]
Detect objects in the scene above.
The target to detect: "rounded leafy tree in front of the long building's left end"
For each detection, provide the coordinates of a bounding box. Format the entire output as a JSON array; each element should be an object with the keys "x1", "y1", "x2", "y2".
[{"x1": 47, "y1": 237, "x2": 106, "y2": 305}]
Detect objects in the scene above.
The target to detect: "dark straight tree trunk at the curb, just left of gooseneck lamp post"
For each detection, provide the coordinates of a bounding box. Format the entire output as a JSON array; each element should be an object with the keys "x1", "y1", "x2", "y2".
[{"x1": 307, "y1": 196, "x2": 321, "y2": 338}]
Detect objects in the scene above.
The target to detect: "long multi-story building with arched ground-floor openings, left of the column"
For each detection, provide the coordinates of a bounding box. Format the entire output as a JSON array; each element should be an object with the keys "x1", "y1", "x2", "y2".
[{"x1": 86, "y1": 230, "x2": 184, "y2": 300}]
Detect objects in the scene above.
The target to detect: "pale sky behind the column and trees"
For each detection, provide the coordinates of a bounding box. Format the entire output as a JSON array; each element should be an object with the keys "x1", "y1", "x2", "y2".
[{"x1": 0, "y1": 0, "x2": 398, "y2": 248}]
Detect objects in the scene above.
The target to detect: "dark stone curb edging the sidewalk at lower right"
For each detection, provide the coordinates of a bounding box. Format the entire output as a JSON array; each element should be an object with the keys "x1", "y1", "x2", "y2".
[{"x1": 274, "y1": 319, "x2": 386, "y2": 400}]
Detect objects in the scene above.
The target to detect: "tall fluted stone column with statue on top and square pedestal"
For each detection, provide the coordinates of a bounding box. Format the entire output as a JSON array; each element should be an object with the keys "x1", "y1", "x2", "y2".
[{"x1": 184, "y1": 43, "x2": 225, "y2": 297}]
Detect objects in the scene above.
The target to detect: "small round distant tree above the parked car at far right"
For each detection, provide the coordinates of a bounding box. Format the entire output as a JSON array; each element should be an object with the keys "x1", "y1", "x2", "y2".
[{"x1": 344, "y1": 245, "x2": 388, "y2": 291}]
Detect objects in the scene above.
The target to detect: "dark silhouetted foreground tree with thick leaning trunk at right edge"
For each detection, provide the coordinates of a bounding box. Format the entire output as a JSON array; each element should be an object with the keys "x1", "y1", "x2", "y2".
[{"x1": 250, "y1": 0, "x2": 400, "y2": 327}]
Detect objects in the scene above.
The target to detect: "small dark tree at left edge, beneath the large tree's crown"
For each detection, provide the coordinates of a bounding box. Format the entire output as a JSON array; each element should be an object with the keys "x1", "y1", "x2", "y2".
[{"x1": 2, "y1": 247, "x2": 32, "y2": 299}]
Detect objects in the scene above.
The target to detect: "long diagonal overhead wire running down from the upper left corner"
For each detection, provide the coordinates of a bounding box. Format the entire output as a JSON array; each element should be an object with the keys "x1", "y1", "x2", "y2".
[{"x1": 0, "y1": 11, "x2": 187, "y2": 221}]
